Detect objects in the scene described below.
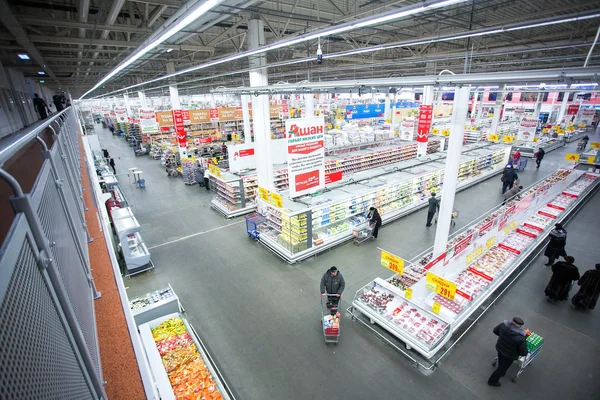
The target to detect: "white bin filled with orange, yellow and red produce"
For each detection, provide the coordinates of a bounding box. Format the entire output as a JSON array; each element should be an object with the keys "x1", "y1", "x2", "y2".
[{"x1": 138, "y1": 313, "x2": 233, "y2": 400}]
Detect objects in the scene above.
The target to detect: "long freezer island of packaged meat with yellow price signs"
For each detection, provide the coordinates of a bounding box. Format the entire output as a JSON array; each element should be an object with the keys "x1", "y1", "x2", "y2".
[{"x1": 351, "y1": 170, "x2": 600, "y2": 359}]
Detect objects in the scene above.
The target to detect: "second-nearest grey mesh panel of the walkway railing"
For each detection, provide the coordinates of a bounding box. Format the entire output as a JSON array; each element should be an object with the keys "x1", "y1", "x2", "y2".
[{"x1": 38, "y1": 173, "x2": 100, "y2": 373}]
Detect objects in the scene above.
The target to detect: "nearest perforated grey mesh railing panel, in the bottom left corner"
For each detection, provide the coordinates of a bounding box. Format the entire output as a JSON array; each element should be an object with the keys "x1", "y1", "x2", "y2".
[{"x1": 0, "y1": 228, "x2": 94, "y2": 400}]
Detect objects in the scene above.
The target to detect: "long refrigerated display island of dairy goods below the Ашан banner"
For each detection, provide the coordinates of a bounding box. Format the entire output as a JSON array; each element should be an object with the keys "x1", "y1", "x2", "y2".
[{"x1": 257, "y1": 145, "x2": 510, "y2": 263}]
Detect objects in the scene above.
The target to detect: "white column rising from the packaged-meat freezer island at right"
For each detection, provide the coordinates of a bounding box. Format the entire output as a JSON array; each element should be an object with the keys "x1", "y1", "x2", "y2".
[{"x1": 433, "y1": 86, "x2": 471, "y2": 260}]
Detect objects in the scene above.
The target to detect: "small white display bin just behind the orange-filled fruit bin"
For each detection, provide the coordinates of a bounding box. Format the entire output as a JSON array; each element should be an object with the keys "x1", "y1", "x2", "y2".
[{"x1": 129, "y1": 285, "x2": 183, "y2": 325}]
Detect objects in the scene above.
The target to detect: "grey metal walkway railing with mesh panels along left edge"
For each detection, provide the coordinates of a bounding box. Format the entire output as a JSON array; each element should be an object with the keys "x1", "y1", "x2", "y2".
[{"x1": 0, "y1": 107, "x2": 107, "y2": 399}]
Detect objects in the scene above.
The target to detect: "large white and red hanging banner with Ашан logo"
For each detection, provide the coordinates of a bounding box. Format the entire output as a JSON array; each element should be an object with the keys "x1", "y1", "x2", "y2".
[{"x1": 285, "y1": 117, "x2": 325, "y2": 198}]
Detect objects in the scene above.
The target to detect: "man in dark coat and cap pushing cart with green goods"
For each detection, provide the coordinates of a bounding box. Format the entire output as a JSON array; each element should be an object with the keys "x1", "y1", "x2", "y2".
[{"x1": 488, "y1": 317, "x2": 527, "y2": 386}]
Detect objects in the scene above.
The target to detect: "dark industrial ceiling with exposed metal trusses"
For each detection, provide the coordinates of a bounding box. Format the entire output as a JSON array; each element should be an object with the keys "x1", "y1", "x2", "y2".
[{"x1": 0, "y1": 0, "x2": 600, "y2": 98}]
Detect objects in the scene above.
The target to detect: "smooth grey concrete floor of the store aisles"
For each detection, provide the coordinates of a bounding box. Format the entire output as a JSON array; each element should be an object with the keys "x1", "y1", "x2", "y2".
[{"x1": 97, "y1": 128, "x2": 600, "y2": 400}]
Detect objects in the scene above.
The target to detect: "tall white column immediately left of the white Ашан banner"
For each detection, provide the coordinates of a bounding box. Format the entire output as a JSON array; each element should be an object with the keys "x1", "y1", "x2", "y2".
[{"x1": 248, "y1": 19, "x2": 274, "y2": 190}]
